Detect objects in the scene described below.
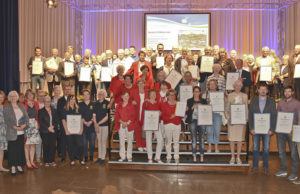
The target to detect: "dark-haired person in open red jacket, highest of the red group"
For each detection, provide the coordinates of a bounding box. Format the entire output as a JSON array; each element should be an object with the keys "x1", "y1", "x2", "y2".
[{"x1": 126, "y1": 51, "x2": 153, "y2": 84}]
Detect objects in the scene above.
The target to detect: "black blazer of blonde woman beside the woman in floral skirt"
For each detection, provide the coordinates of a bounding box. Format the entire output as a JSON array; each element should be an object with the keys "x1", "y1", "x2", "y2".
[{"x1": 38, "y1": 107, "x2": 58, "y2": 133}]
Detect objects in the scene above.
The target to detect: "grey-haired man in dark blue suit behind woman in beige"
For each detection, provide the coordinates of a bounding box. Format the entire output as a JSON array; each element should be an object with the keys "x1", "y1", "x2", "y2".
[{"x1": 233, "y1": 59, "x2": 253, "y2": 93}]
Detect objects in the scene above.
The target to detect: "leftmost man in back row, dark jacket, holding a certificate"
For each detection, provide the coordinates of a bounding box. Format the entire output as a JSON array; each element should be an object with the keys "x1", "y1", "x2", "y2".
[{"x1": 27, "y1": 47, "x2": 46, "y2": 92}]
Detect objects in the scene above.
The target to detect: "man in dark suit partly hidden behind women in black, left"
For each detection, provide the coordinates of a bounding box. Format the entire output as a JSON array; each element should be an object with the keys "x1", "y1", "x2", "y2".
[{"x1": 57, "y1": 85, "x2": 71, "y2": 162}]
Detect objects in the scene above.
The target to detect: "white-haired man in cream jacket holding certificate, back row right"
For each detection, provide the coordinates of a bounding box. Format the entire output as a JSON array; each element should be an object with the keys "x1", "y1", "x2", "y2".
[{"x1": 254, "y1": 47, "x2": 279, "y2": 97}]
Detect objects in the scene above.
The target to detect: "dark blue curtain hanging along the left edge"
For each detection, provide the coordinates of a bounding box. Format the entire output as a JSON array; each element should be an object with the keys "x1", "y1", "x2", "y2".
[{"x1": 0, "y1": 0, "x2": 20, "y2": 94}]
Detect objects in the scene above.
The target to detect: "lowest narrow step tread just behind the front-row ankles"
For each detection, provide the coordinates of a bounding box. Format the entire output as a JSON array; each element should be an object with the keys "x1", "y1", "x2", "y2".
[{"x1": 111, "y1": 149, "x2": 247, "y2": 156}]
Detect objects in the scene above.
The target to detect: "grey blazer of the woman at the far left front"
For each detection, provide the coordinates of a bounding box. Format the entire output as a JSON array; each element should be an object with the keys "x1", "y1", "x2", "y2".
[{"x1": 3, "y1": 104, "x2": 29, "y2": 141}]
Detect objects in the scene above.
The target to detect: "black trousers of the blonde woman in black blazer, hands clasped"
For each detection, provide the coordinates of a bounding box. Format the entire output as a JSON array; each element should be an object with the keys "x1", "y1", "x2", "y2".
[{"x1": 41, "y1": 133, "x2": 56, "y2": 163}]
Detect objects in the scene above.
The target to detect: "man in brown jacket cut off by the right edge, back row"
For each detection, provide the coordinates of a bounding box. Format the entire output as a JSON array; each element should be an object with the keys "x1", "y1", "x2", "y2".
[{"x1": 289, "y1": 44, "x2": 300, "y2": 100}]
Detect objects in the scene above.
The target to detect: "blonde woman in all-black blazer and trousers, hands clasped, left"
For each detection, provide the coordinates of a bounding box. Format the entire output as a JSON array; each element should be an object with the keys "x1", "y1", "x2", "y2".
[{"x1": 38, "y1": 96, "x2": 58, "y2": 167}]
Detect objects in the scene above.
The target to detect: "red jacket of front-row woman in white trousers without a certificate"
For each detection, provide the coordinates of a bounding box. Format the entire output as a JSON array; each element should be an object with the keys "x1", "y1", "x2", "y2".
[{"x1": 115, "y1": 102, "x2": 137, "y2": 131}]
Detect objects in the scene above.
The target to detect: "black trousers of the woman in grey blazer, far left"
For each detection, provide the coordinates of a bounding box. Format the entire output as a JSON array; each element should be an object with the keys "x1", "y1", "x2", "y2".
[{"x1": 7, "y1": 135, "x2": 26, "y2": 167}]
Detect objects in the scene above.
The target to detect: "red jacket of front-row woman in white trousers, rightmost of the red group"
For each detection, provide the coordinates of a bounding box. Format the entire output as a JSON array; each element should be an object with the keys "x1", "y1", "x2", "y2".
[{"x1": 160, "y1": 102, "x2": 181, "y2": 125}]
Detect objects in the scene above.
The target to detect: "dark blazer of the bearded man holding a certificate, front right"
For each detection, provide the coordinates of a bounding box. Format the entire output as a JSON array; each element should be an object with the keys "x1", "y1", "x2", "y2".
[{"x1": 248, "y1": 96, "x2": 277, "y2": 132}]
